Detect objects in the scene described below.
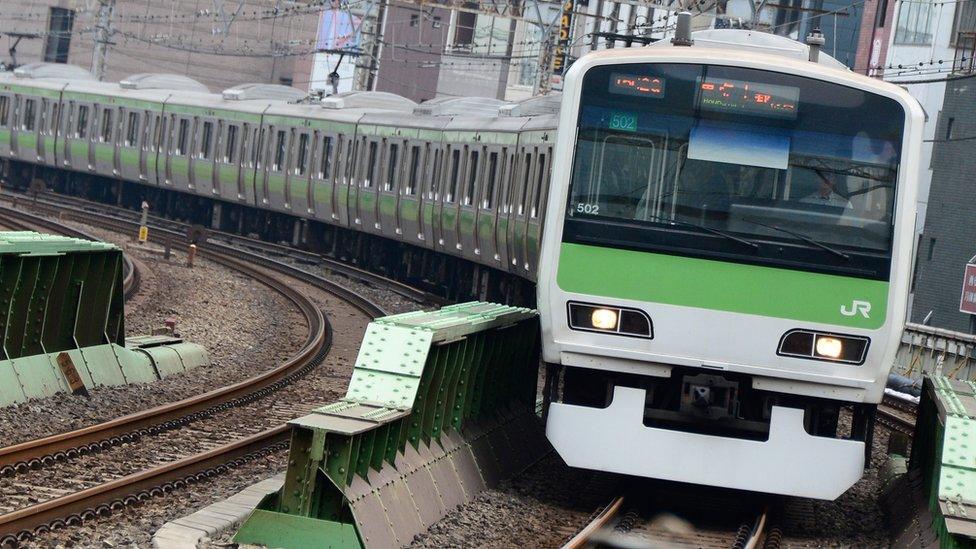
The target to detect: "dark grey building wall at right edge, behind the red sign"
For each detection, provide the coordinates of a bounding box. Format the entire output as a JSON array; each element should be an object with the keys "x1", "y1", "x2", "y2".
[{"x1": 911, "y1": 80, "x2": 976, "y2": 332}]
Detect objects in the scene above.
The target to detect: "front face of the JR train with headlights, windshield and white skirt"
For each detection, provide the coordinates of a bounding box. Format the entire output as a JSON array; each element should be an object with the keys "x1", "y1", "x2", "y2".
[{"x1": 538, "y1": 31, "x2": 923, "y2": 499}]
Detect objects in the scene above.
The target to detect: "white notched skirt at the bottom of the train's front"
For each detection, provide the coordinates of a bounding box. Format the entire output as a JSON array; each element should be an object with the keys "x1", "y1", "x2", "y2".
[{"x1": 546, "y1": 387, "x2": 864, "y2": 500}]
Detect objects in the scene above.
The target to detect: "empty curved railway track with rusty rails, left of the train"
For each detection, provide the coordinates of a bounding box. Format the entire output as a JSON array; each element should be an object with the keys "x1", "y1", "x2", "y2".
[{"x1": 0, "y1": 203, "x2": 396, "y2": 546}]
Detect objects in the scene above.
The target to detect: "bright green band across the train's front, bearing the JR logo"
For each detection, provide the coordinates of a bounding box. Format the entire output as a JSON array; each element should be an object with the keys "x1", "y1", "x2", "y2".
[{"x1": 556, "y1": 242, "x2": 888, "y2": 330}]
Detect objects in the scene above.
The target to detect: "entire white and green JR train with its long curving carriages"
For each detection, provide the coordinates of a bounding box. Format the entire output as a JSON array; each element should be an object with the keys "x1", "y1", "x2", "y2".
[{"x1": 0, "y1": 31, "x2": 923, "y2": 499}]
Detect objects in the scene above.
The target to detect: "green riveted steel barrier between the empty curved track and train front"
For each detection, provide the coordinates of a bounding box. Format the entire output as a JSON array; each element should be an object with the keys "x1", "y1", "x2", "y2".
[{"x1": 234, "y1": 302, "x2": 549, "y2": 548}]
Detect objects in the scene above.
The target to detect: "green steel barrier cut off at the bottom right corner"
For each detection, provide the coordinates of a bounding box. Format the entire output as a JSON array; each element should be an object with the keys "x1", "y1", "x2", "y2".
[{"x1": 909, "y1": 376, "x2": 976, "y2": 548}]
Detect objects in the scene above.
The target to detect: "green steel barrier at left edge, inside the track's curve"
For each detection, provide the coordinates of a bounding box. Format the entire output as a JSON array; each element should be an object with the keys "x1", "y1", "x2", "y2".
[{"x1": 0, "y1": 231, "x2": 209, "y2": 406}]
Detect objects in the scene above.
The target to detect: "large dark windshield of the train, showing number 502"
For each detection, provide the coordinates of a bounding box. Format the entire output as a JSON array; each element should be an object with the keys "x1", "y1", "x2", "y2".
[{"x1": 564, "y1": 64, "x2": 905, "y2": 279}]
